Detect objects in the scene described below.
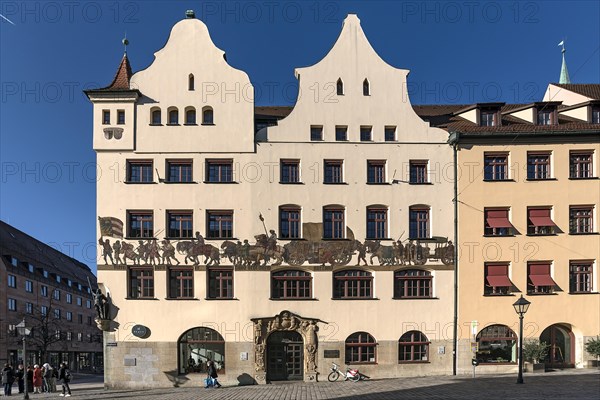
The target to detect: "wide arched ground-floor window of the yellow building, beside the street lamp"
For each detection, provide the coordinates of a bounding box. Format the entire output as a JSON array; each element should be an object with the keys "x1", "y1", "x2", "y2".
[{"x1": 476, "y1": 325, "x2": 517, "y2": 364}]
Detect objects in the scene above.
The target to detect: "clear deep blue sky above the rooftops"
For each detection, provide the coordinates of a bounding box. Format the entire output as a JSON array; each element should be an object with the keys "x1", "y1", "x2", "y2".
[{"x1": 0, "y1": 1, "x2": 600, "y2": 271}]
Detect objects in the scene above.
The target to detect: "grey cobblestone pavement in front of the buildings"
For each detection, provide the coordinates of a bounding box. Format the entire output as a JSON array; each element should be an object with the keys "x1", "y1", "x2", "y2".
[{"x1": 13, "y1": 370, "x2": 600, "y2": 400}]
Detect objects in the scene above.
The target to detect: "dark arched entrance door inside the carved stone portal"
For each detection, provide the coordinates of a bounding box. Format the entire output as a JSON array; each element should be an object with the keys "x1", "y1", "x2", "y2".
[{"x1": 267, "y1": 331, "x2": 304, "y2": 381}]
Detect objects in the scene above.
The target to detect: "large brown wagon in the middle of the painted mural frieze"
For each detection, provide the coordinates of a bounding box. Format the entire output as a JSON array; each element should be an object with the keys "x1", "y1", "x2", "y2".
[{"x1": 283, "y1": 222, "x2": 360, "y2": 266}]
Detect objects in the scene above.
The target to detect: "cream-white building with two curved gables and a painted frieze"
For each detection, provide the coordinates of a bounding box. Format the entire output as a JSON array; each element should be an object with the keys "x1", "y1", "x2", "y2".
[{"x1": 86, "y1": 11, "x2": 453, "y2": 387}]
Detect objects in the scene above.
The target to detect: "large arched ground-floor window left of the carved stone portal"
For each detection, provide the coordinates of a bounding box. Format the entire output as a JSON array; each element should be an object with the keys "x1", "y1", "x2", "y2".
[{"x1": 177, "y1": 327, "x2": 225, "y2": 374}]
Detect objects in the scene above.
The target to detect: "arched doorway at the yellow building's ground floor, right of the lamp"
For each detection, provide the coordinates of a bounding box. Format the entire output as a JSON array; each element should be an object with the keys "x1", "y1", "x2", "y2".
[{"x1": 540, "y1": 324, "x2": 575, "y2": 368}]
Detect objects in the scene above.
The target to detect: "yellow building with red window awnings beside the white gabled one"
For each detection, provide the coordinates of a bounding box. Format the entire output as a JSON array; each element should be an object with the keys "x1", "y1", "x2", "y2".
[{"x1": 444, "y1": 93, "x2": 600, "y2": 373}]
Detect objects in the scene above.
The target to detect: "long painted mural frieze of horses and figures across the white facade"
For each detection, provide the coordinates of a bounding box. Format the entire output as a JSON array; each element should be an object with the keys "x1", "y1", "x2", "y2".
[{"x1": 98, "y1": 217, "x2": 454, "y2": 270}]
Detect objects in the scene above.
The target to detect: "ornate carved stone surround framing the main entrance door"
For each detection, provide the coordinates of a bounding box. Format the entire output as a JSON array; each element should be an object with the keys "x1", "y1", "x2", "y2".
[{"x1": 252, "y1": 310, "x2": 326, "y2": 384}]
